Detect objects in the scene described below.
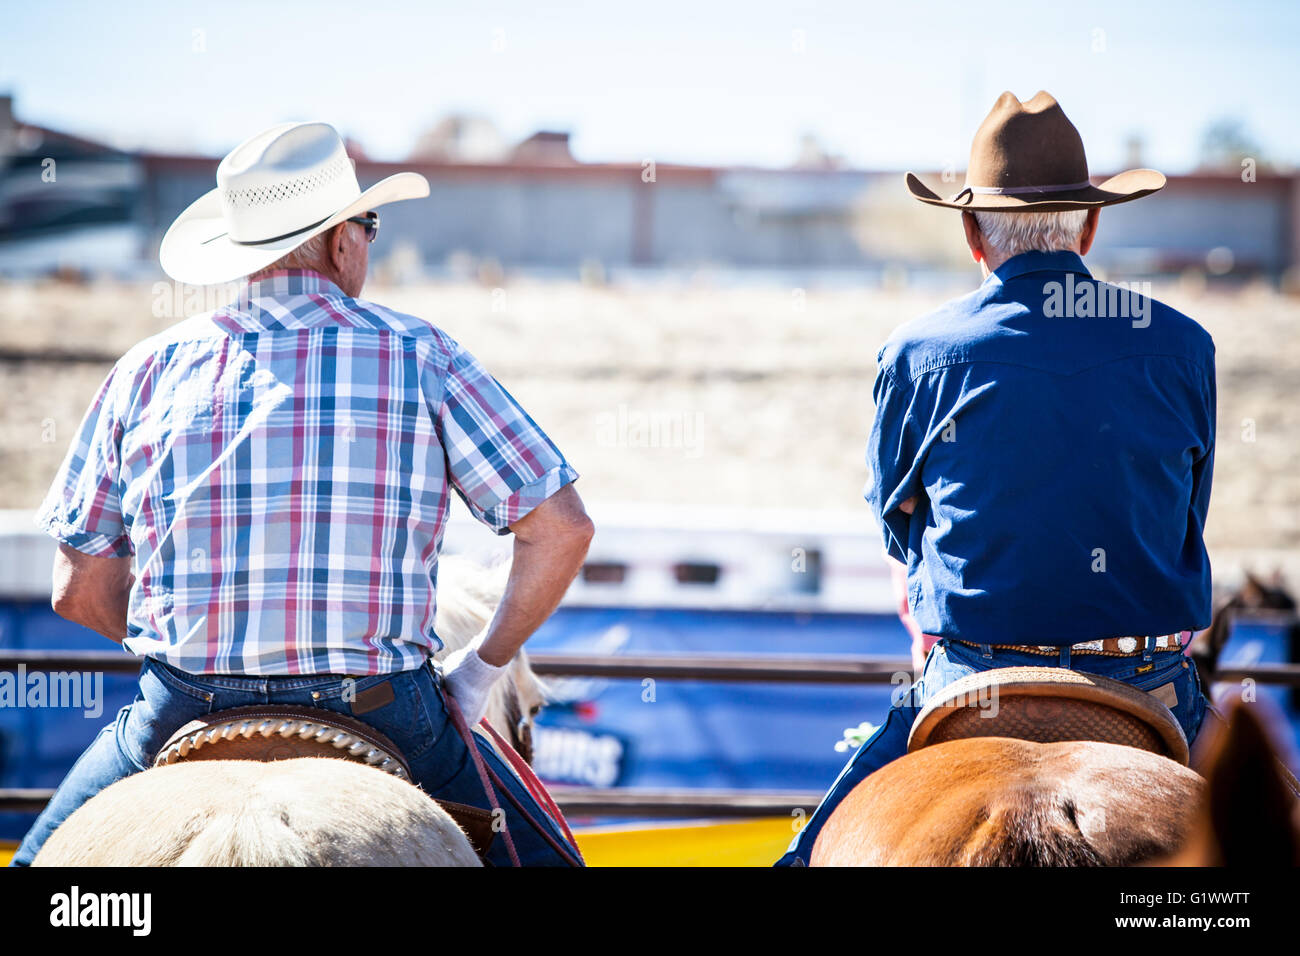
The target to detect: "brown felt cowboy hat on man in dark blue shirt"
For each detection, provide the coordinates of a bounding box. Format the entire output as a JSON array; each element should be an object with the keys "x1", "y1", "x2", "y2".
[{"x1": 906, "y1": 90, "x2": 1165, "y2": 212}]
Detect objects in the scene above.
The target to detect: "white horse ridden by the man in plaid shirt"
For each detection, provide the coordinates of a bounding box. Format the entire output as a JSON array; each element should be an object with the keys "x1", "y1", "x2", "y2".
[{"x1": 33, "y1": 555, "x2": 546, "y2": 866}]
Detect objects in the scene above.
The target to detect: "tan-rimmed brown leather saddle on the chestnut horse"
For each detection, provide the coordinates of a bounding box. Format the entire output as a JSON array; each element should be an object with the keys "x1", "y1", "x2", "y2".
[{"x1": 907, "y1": 667, "x2": 1188, "y2": 766}]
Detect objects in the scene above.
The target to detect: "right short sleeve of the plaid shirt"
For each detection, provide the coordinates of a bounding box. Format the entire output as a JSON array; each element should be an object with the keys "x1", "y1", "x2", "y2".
[{"x1": 437, "y1": 347, "x2": 577, "y2": 535}]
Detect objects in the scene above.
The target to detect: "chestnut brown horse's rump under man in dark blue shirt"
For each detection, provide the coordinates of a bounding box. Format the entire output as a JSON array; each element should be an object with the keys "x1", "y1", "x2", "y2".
[{"x1": 810, "y1": 737, "x2": 1203, "y2": 866}]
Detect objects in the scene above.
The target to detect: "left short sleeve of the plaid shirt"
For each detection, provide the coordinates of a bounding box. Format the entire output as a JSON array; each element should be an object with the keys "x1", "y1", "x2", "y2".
[{"x1": 36, "y1": 368, "x2": 134, "y2": 558}]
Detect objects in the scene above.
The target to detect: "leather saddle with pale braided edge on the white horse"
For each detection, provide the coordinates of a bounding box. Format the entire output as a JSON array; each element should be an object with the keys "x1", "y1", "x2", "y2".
[{"x1": 153, "y1": 706, "x2": 495, "y2": 860}]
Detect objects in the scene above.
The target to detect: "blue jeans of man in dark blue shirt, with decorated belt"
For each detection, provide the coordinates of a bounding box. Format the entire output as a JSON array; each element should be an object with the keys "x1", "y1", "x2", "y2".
[{"x1": 776, "y1": 640, "x2": 1208, "y2": 866}]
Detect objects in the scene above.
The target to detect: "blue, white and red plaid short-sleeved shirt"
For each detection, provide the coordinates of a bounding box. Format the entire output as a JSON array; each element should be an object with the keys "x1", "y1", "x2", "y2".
[{"x1": 36, "y1": 271, "x2": 577, "y2": 675}]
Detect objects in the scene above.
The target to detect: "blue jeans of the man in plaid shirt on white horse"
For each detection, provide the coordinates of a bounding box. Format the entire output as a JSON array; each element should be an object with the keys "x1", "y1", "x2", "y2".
[{"x1": 12, "y1": 659, "x2": 576, "y2": 866}]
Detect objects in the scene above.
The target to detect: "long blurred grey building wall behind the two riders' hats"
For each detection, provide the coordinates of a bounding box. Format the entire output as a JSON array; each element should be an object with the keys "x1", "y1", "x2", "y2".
[{"x1": 104, "y1": 156, "x2": 1300, "y2": 277}]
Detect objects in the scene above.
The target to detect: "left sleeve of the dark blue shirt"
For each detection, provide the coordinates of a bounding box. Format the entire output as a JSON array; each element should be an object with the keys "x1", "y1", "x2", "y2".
[{"x1": 865, "y1": 365, "x2": 930, "y2": 564}]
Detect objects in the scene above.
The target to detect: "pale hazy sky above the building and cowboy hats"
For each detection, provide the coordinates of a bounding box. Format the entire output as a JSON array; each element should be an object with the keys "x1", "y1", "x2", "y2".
[{"x1": 0, "y1": 0, "x2": 1300, "y2": 173}]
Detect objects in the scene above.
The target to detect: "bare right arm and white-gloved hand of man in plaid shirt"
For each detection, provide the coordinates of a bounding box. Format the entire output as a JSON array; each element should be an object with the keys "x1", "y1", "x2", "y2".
[{"x1": 443, "y1": 485, "x2": 595, "y2": 726}]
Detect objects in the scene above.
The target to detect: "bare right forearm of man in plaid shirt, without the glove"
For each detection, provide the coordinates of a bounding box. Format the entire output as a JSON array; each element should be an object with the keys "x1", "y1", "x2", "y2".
[{"x1": 478, "y1": 515, "x2": 590, "y2": 666}]
